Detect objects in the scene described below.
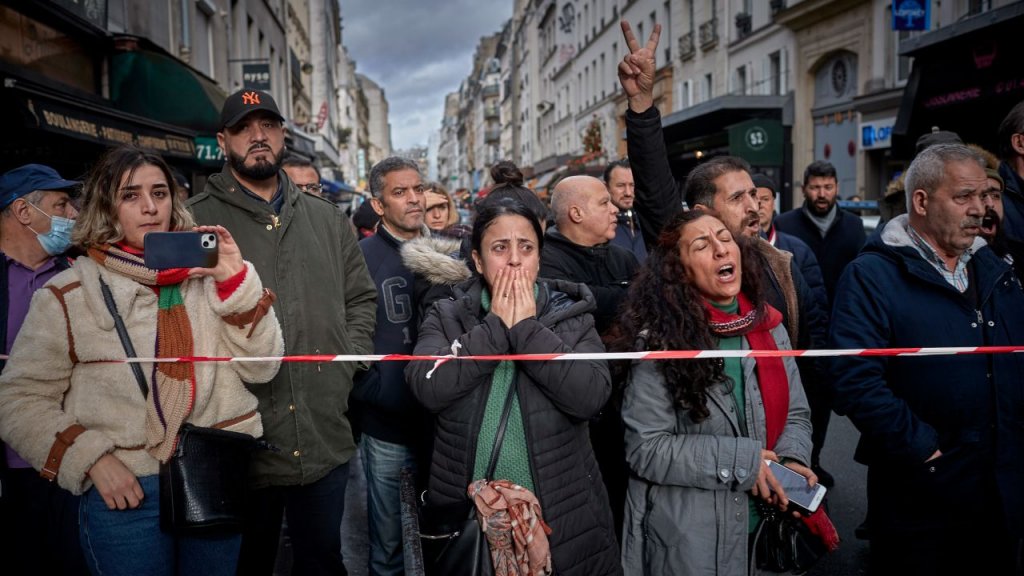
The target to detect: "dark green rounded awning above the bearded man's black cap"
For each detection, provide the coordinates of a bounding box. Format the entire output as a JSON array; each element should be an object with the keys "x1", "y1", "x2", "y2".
[{"x1": 110, "y1": 36, "x2": 227, "y2": 134}]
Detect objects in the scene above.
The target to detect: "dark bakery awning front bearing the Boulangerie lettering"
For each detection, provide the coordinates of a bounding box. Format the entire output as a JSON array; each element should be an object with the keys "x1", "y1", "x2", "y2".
[{"x1": 0, "y1": 75, "x2": 196, "y2": 160}]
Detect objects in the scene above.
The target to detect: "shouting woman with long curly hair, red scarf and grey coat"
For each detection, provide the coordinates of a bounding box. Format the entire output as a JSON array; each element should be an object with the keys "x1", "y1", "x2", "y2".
[{"x1": 615, "y1": 211, "x2": 817, "y2": 576}]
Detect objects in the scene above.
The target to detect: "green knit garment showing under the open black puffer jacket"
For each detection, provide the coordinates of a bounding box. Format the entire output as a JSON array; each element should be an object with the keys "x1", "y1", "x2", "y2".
[{"x1": 473, "y1": 287, "x2": 537, "y2": 492}]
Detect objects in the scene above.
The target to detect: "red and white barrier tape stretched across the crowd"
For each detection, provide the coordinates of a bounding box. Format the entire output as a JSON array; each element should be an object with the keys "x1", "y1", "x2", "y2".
[{"x1": 0, "y1": 345, "x2": 1024, "y2": 364}]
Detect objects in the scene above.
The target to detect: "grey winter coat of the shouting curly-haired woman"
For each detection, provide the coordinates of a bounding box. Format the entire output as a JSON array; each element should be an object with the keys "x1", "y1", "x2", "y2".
[{"x1": 623, "y1": 325, "x2": 811, "y2": 576}]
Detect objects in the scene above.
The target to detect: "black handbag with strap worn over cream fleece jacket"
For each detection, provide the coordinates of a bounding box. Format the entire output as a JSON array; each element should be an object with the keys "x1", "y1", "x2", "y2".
[{"x1": 99, "y1": 279, "x2": 260, "y2": 536}]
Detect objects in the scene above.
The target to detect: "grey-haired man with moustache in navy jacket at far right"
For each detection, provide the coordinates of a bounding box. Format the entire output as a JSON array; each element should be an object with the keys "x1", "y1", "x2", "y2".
[{"x1": 829, "y1": 145, "x2": 1024, "y2": 574}]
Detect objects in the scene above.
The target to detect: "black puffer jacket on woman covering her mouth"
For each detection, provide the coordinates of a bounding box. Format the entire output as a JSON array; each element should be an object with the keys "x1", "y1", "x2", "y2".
[{"x1": 406, "y1": 278, "x2": 622, "y2": 576}]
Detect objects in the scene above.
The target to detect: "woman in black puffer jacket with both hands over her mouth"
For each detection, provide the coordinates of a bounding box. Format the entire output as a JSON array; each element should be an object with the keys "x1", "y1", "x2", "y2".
[{"x1": 406, "y1": 199, "x2": 622, "y2": 576}]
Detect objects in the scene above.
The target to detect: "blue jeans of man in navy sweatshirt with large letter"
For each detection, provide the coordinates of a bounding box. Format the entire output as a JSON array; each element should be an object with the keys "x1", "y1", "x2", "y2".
[{"x1": 359, "y1": 434, "x2": 416, "y2": 576}]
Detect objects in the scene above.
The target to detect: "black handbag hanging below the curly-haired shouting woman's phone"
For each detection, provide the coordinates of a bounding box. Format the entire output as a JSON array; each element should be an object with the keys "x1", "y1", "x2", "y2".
[{"x1": 753, "y1": 502, "x2": 828, "y2": 574}]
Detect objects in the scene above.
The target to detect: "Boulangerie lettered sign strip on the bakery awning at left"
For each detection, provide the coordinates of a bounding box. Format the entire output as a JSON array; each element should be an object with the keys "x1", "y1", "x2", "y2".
[{"x1": 26, "y1": 98, "x2": 196, "y2": 158}]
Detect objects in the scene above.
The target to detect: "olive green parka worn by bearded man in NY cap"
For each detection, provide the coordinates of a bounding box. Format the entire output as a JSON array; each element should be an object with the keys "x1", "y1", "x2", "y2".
[{"x1": 188, "y1": 165, "x2": 377, "y2": 488}]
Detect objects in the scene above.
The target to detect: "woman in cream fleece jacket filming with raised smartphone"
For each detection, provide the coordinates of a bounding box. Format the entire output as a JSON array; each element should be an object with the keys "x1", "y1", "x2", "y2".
[{"x1": 0, "y1": 148, "x2": 284, "y2": 575}]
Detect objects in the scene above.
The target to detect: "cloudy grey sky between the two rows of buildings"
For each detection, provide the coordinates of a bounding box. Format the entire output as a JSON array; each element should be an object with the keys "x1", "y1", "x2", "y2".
[{"x1": 341, "y1": 0, "x2": 513, "y2": 150}]
